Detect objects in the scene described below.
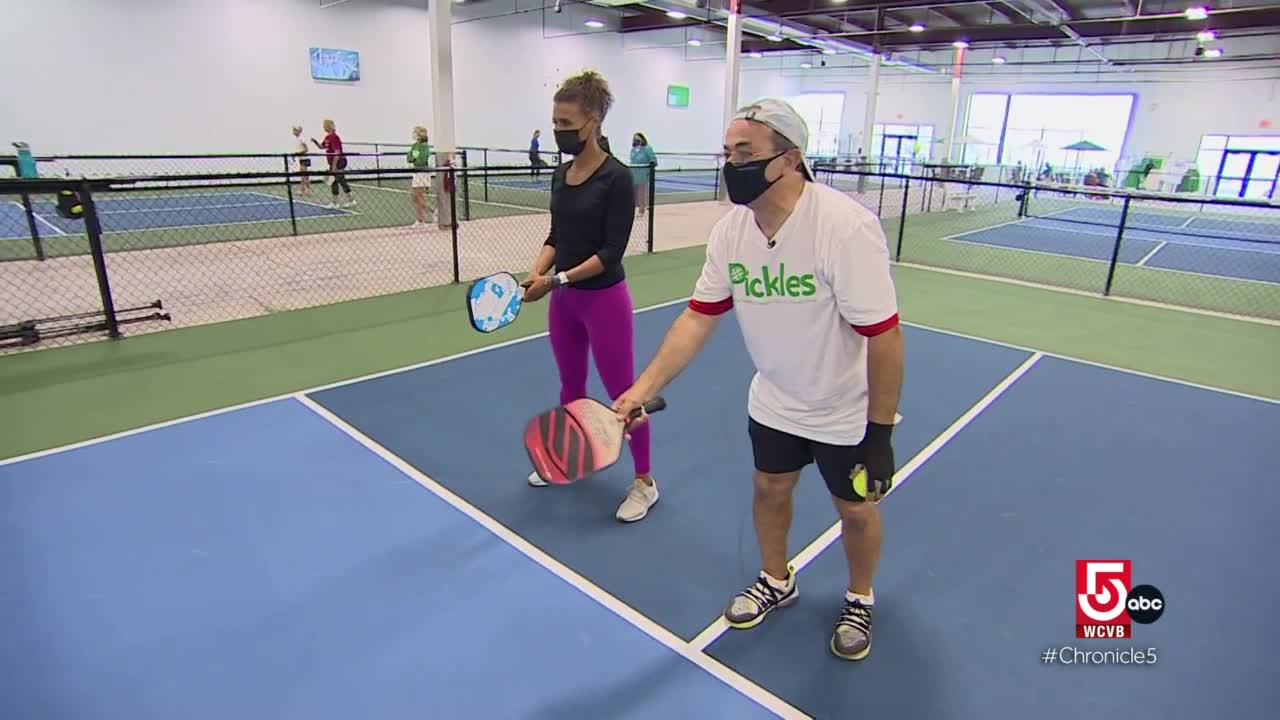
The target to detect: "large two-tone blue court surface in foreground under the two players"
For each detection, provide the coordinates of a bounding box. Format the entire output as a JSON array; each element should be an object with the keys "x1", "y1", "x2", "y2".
[{"x1": 0, "y1": 304, "x2": 1280, "y2": 720}]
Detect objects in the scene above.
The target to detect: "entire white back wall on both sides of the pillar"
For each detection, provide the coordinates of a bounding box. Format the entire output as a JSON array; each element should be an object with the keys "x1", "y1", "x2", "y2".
[{"x1": 0, "y1": 0, "x2": 790, "y2": 154}]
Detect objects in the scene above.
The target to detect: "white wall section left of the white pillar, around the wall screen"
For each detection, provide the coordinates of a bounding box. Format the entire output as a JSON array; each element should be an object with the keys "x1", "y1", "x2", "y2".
[{"x1": 0, "y1": 0, "x2": 431, "y2": 154}]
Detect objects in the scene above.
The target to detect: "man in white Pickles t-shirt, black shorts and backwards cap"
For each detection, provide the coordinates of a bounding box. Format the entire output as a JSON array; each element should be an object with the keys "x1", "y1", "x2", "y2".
[{"x1": 614, "y1": 100, "x2": 902, "y2": 660}]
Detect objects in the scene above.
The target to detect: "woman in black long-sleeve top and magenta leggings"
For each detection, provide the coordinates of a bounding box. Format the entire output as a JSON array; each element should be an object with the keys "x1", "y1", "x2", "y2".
[{"x1": 521, "y1": 70, "x2": 658, "y2": 523}]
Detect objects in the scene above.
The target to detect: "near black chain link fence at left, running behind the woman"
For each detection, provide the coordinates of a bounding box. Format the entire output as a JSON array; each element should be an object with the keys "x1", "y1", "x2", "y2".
[{"x1": 0, "y1": 161, "x2": 653, "y2": 352}]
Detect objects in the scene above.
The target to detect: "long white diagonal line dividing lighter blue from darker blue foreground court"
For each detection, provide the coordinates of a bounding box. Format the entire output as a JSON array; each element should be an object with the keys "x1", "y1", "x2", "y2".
[{"x1": 293, "y1": 393, "x2": 808, "y2": 719}]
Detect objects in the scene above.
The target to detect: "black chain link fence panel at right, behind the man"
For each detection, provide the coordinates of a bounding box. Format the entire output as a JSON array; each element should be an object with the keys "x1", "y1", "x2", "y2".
[{"x1": 817, "y1": 168, "x2": 1280, "y2": 320}]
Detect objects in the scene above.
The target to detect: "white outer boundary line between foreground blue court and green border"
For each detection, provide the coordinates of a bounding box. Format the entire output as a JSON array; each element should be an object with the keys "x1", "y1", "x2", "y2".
[{"x1": 0, "y1": 286, "x2": 1280, "y2": 468}]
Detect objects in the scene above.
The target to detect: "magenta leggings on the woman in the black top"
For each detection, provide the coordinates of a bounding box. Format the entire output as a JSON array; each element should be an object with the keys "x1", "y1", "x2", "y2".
[{"x1": 548, "y1": 282, "x2": 649, "y2": 475}]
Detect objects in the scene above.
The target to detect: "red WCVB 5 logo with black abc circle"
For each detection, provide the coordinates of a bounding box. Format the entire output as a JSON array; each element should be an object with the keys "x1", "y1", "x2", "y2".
[{"x1": 1075, "y1": 560, "x2": 1165, "y2": 639}]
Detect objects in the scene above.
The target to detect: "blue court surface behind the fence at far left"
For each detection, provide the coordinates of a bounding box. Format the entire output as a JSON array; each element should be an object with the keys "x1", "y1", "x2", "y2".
[{"x1": 0, "y1": 192, "x2": 353, "y2": 240}]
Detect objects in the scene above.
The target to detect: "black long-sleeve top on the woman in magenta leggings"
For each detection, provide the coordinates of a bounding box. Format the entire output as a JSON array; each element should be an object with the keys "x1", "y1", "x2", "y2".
[{"x1": 547, "y1": 155, "x2": 636, "y2": 290}]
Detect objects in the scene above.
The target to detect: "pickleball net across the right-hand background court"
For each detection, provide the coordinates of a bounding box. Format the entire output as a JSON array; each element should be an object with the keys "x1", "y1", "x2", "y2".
[{"x1": 1021, "y1": 186, "x2": 1280, "y2": 251}]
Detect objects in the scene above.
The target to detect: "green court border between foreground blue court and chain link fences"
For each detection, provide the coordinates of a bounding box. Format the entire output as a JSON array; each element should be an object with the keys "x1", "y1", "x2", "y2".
[{"x1": 0, "y1": 244, "x2": 1280, "y2": 457}]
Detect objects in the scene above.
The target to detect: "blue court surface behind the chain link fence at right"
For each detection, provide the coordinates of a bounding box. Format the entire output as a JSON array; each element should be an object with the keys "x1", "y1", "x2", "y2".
[{"x1": 947, "y1": 208, "x2": 1280, "y2": 283}]
